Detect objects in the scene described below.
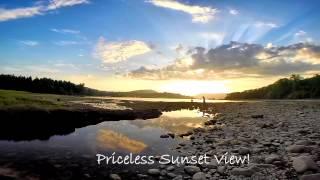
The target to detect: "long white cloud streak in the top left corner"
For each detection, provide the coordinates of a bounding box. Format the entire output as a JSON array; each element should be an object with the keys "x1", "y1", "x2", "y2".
[{"x1": 0, "y1": 0, "x2": 89, "y2": 22}]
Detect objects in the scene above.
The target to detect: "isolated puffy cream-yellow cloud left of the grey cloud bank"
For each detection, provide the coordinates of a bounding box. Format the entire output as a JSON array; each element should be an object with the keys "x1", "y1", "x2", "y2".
[{"x1": 94, "y1": 37, "x2": 152, "y2": 63}]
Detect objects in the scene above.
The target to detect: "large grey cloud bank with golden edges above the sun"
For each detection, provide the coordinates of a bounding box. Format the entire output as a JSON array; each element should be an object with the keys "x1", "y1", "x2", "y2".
[{"x1": 128, "y1": 42, "x2": 320, "y2": 80}]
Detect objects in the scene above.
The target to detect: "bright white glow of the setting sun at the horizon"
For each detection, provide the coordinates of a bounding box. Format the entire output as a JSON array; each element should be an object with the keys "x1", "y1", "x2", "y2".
[{"x1": 160, "y1": 80, "x2": 230, "y2": 96}]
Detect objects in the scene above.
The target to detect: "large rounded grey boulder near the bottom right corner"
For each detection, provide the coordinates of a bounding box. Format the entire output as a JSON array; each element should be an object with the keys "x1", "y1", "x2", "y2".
[{"x1": 292, "y1": 156, "x2": 318, "y2": 173}]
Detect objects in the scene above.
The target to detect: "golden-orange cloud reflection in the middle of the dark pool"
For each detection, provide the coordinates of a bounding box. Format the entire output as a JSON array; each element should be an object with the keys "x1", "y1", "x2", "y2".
[{"x1": 97, "y1": 129, "x2": 147, "y2": 153}]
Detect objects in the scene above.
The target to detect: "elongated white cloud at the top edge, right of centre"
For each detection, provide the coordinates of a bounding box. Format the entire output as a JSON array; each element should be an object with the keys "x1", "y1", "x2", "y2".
[{"x1": 147, "y1": 0, "x2": 218, "y2": 23}]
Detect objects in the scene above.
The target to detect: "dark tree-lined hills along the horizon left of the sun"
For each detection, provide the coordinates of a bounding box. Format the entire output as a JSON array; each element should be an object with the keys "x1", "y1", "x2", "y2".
[{"x1": 0, "y1": 74, "x2": 191, "y2": 98}]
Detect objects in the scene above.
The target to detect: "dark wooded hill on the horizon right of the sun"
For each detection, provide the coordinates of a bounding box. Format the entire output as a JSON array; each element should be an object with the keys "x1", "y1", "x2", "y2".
[{"x1": 225, "y1": 75, "x2": 320, "y2": 100}]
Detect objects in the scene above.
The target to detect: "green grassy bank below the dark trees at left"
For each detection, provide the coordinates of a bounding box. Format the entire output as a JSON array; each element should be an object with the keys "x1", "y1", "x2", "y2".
[{"x1": 0, "y1": 90, "x2": 70, "y2": 109}]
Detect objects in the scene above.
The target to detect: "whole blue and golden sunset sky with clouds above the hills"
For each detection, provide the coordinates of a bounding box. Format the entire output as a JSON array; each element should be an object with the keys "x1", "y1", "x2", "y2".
[{"x1": 0, "y1": 0, "x2": 320, "y2": 95}]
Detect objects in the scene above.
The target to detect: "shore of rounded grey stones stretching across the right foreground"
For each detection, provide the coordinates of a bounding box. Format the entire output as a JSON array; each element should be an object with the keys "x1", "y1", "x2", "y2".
[{"x1": 135, "y1": 101, "x2": 320, "y2": 180}]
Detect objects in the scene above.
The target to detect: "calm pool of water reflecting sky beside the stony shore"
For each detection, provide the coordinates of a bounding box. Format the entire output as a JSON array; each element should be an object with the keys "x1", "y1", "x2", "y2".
[{"x1": 0, "y1": 110, "x2": 207, "y2": 175}]
